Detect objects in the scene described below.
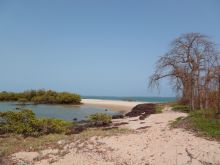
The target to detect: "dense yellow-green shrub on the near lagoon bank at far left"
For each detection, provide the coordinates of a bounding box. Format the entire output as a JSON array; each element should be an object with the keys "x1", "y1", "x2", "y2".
[{"x1": 0, "y1": 110, "x2": 71, "y2": 136}]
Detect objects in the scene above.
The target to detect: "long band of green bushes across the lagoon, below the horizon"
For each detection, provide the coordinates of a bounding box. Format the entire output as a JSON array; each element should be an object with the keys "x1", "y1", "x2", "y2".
[{"x1": 0, "y1": 90, "x2": 81, "y2": 104}]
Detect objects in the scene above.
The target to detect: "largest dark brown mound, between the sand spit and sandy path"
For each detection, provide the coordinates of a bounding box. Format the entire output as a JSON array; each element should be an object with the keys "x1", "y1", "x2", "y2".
[{"x1": 125, "y1": 104, "x2": 156, "y2": 120}]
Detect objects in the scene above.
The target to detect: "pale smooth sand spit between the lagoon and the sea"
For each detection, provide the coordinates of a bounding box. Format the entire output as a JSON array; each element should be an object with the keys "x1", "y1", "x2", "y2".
[{"x1": 81, "y1": 99, "x2": 148, "y2": 113}]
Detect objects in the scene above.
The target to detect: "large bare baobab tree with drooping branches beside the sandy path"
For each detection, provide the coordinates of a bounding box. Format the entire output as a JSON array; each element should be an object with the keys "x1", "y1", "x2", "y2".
[{"x1": 149, "y1": 33, "x2": 219, "y2": 110}]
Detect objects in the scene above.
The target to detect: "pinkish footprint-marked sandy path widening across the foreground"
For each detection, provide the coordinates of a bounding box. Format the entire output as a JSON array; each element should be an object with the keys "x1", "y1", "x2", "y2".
[{"x1": 12, "y1": 108, "x2": 220, "y2": 165}]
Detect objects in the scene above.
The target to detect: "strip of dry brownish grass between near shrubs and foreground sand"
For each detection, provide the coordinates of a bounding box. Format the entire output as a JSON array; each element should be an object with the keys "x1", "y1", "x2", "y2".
[{"x1": 0, "y1": 128, "x2": 132, "y2": 158}]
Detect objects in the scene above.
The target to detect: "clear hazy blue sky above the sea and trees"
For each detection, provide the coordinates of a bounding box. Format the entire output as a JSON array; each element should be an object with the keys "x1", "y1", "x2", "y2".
[{"x1": 0, "y1": 0, "x2": 220, "y2": 96}]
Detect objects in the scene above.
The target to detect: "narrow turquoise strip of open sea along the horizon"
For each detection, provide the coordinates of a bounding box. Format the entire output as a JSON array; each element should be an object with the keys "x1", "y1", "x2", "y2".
[{"x1": 82, "y1": 96, "x2": 177, "y2": 103}]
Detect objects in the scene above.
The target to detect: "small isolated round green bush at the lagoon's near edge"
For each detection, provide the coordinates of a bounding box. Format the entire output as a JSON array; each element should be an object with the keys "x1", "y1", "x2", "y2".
[{"x1": 88, "y1": 113, "x2": 112, "y2": 124}]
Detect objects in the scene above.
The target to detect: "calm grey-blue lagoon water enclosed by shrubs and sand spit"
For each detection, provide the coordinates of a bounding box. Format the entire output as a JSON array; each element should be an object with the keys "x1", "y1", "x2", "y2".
[{"x1": 0, "y1": 102, "x2": 118, "y2": 121}]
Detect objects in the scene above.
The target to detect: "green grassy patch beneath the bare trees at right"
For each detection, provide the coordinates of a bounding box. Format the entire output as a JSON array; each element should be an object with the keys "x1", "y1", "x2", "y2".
[{"x1": 172, "y1": 110, "x2": 220, "y2": 140}]
